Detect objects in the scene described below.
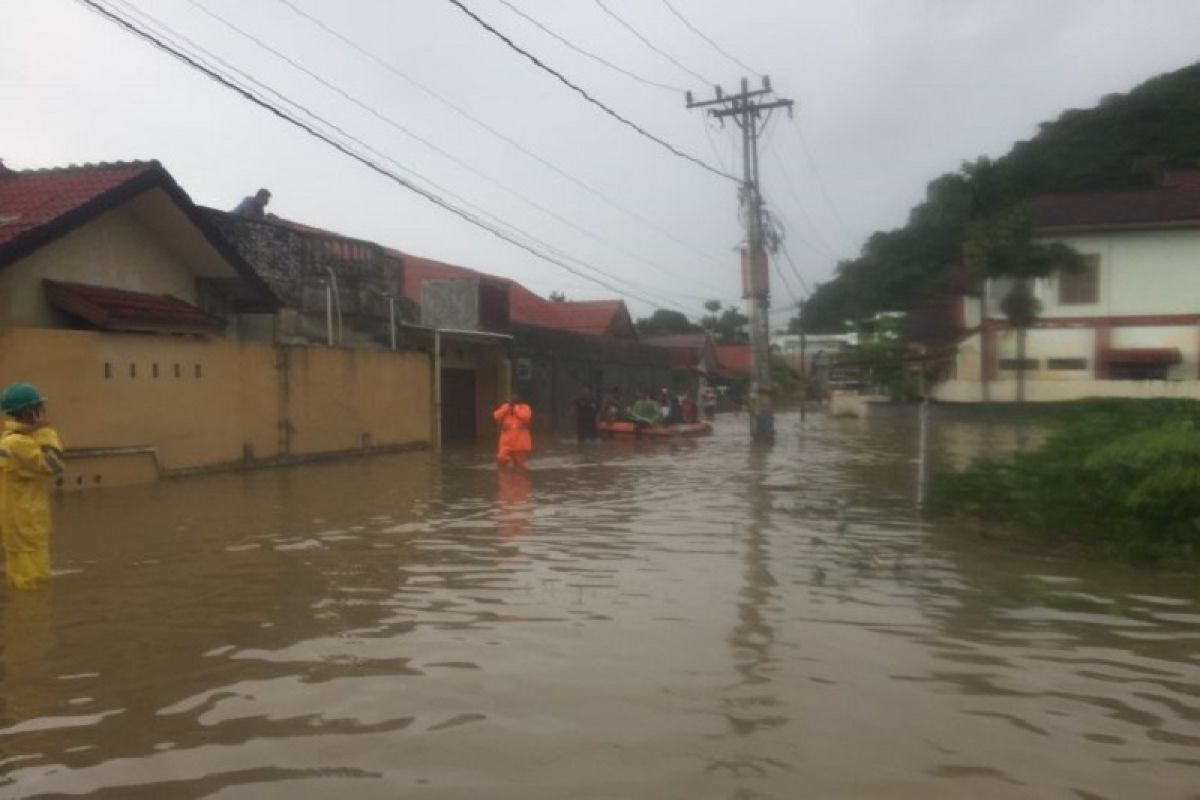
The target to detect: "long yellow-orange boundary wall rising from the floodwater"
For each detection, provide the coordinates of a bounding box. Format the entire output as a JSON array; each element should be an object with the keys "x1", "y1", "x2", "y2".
[{"x1": 0, "y1": 329, "x2": 432, "y2": 486}]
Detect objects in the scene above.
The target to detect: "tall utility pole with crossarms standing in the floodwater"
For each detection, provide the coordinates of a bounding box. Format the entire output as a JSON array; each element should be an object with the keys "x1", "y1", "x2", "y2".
[{"x1": 688, "y1": 76, "x2": 792, "y2": 441}]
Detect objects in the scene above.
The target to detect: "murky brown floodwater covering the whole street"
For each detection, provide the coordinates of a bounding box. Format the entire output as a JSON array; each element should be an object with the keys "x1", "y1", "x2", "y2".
[{"x1": 0, "y1": 414, "x2": 1200, "y2": 800}]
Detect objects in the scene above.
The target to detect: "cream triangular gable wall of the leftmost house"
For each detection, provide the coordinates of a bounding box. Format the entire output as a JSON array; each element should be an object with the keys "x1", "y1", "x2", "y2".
[{"x1": 0, "y1": 205, "x2": 198, "y2": 329}]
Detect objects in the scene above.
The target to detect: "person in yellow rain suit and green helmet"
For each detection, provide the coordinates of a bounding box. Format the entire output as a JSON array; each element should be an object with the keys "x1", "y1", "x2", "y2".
[{"x1": 0, "y1": 384, "x2": 62, "y2": 589}]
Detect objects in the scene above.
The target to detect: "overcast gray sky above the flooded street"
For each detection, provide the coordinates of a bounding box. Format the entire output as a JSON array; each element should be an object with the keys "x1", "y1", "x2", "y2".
[{"x1": 0, "y1": 0, "x2": 1200, "y2": 324}]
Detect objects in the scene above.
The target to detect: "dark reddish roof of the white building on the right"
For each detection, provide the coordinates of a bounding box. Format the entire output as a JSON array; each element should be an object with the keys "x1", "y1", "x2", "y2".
[{"x1": 1030, "y1": 172, "x2": 1200, "y2": 229}]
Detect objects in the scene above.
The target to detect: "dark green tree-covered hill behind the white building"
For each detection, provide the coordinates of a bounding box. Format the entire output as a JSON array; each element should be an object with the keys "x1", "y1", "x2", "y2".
[{"x1": 804, "y1": 62, "x2": 1200, "y2": 331}]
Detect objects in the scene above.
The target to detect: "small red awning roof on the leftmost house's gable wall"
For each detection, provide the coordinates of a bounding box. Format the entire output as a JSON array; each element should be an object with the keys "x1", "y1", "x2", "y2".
[{"x1": 42, "y1": 281, "x2": 226, "y2": 333}]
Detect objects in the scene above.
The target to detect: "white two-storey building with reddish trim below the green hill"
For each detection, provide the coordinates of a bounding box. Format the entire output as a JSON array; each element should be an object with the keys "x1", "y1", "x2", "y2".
[{"x1": 935, "y1": 170, "x2": 1200, "y2": 402}]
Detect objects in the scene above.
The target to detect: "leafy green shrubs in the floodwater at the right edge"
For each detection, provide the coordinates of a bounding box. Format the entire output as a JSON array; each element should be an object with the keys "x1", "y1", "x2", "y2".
[{"x1": 931, "y1": 399, "x2": 1200, "y2": 563}]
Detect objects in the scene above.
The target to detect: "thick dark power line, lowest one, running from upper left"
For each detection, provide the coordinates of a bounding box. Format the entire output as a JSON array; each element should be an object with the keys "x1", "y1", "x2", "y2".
[{"x1": 77, "y1": 0, "x2": 696, "y2": 316}]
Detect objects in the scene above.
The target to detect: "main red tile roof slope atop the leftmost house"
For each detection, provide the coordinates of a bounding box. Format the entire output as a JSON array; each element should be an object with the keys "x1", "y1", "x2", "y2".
[{"x1": 0, "y1": 161, "x2": 161, "y2": 247}]
